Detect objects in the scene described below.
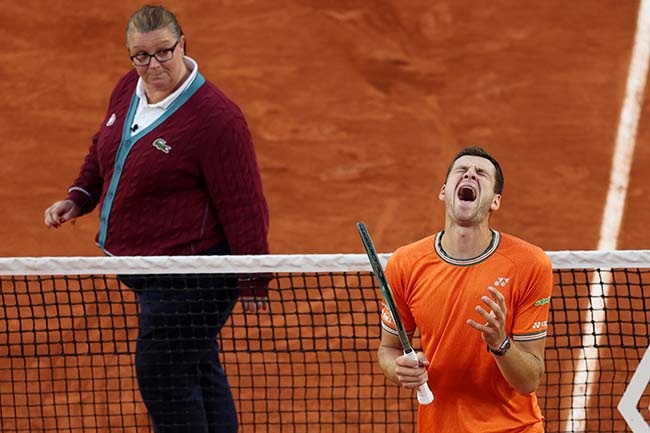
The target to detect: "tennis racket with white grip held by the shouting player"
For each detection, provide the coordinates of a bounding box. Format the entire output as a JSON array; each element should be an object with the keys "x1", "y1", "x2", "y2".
[{"x1": 357, "y1": 222, "x2": 433, "y2": 404}]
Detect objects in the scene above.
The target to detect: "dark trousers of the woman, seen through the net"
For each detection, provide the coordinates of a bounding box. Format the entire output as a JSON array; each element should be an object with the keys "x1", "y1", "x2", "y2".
[{"x1": 120, "y1": 250, "x2": 239, "y2": 433}]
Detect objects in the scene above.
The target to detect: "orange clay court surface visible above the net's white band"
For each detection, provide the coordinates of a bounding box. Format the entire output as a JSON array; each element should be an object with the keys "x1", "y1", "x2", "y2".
[{"x1": 0, "y1": 0, "x2": 650, "y2": 432}]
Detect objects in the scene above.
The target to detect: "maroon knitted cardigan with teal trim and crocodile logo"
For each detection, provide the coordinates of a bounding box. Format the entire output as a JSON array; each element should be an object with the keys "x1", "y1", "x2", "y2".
[{"x1": 68, "y1": 70, "x2": 269, "y2": 264}]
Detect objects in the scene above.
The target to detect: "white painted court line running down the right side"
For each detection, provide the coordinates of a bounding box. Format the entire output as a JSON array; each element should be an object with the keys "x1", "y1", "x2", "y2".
[{"x1": 565, "y1": 0, "x2": 650, "y2": 433}]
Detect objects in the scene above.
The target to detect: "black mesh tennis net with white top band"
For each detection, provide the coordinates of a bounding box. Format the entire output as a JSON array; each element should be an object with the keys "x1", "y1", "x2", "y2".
[{"x1": 0, "y1": 251, "x2": 650, "y2": 433}]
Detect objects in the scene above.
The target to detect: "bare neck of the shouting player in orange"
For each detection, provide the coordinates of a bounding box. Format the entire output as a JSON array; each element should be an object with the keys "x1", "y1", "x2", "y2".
[{"x1": 440, "y1": 225, "x2": 493, "y2": 260}]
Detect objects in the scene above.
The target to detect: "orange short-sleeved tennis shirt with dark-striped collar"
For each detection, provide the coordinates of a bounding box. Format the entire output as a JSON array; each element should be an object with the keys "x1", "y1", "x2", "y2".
[{"x1": 382, "y1": 231, "x2": 553, "y2": 433}]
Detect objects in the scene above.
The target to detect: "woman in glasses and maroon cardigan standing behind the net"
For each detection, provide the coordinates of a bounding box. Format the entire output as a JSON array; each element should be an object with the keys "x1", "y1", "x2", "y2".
[{"x1": 45, "y1": 5, "x2": 269, "y2": 433}]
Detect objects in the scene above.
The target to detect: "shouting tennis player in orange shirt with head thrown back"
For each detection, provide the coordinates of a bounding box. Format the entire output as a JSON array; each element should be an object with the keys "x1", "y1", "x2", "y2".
[{"x1": 378, "y1": 147, "x2": 553, "y2": 433}]
